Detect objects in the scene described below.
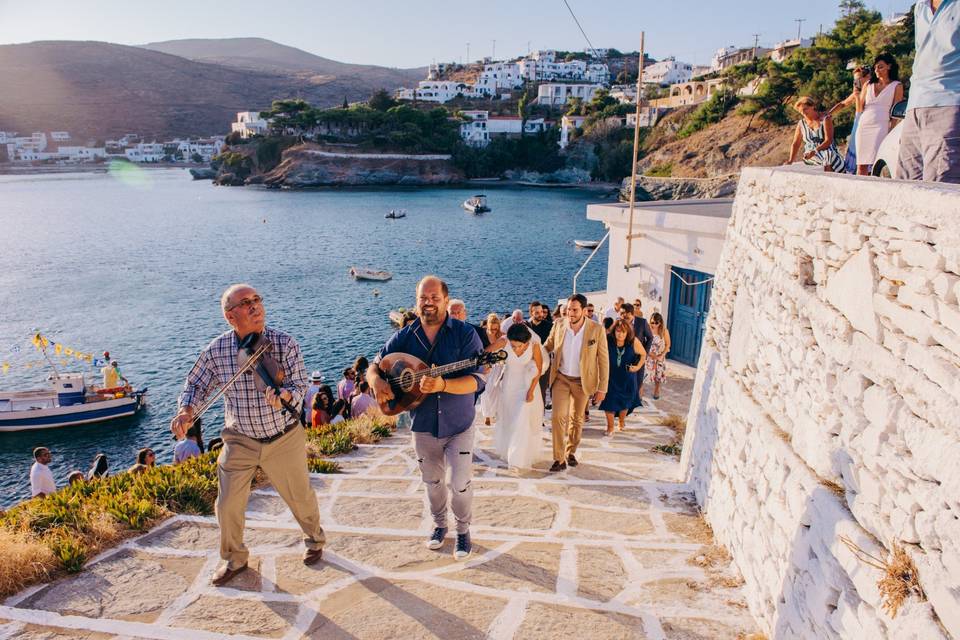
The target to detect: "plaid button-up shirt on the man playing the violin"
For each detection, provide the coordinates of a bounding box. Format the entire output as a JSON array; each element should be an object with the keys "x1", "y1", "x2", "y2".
[{"x1": 180, "y1": 327, "x2": 307, "y2": 438}]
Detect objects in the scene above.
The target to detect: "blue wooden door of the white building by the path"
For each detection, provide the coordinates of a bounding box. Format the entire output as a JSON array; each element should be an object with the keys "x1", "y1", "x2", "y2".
[{"x1": 667, "y1": 267, "x2": 713, "y2": 367}]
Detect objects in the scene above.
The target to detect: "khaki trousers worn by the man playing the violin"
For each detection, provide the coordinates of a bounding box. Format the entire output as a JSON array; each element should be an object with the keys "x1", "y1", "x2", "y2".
[{"x1": 216, "y1": 427, "x2": 326, "y2": 569}]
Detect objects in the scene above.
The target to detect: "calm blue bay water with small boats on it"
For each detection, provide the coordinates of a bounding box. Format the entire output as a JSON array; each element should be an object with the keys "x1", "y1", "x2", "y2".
[{"x1": 0, "y1": 170, "x2": 606, "y2": 505}]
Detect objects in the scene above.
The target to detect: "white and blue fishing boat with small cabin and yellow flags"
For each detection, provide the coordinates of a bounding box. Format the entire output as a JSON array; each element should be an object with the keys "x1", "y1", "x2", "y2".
[{"x1": 0, "y1": 373, "x2": 147, "y2": 433}]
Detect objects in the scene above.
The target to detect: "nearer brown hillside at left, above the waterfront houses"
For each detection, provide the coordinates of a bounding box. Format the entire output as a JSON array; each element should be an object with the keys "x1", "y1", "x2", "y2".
[{"x1": 0, "y1": 41, "x2": 420, "y2": 139}]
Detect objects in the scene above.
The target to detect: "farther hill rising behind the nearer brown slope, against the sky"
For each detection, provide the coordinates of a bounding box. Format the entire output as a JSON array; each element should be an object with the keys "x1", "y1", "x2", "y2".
[{"x1": 142, "y1": 38, "x2": 426, "y2": 89}]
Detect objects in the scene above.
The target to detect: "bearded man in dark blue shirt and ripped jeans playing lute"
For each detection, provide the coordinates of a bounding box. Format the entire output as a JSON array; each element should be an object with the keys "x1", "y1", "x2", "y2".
[{"x1": 367, "y1": 276, "x2": 484, "y2": 560}]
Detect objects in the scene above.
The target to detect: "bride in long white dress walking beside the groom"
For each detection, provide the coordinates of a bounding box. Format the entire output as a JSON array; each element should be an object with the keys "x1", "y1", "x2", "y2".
[{"x1": 493, "y1": 324, "x2": 543, "y2": 469}]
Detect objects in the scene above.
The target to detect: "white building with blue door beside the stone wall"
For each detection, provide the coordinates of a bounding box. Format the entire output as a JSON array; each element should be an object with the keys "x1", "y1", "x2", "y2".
[{"x1": 587, "y1": 199, "x2": 733, "y2": 366}]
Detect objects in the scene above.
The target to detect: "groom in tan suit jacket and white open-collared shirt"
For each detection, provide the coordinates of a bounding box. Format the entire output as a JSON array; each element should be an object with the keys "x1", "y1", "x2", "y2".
[{"x1": 543, "y1": 293, "x2": 610, "y2": 471}]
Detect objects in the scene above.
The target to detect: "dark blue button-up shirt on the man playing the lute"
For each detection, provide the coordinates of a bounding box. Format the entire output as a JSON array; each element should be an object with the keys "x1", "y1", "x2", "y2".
[{"x1": 375, "y1": 315, "x2": 485, "y2": 438}]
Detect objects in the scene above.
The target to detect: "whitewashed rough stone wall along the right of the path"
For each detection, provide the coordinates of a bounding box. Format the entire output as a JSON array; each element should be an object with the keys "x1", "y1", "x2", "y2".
[{"x1": 683, "y1": 168, "x2": 960, "y2": 640}]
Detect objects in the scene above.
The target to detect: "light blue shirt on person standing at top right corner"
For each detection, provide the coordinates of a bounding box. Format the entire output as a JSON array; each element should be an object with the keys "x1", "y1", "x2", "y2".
[{"x1": 907, "y1": 0, "x2": 960, "y2": 109}]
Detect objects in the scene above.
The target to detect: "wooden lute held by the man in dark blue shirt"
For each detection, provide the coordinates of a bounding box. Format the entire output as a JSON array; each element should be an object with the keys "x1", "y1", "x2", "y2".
[{"x1": 377, "y1": 349, "x2": 507, "y2": 416}]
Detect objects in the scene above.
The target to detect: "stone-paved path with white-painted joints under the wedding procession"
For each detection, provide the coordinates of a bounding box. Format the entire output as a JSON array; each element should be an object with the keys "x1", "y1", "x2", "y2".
[{"x1": 0, "y1": 370, "x2": 755, "y2": 640}]
